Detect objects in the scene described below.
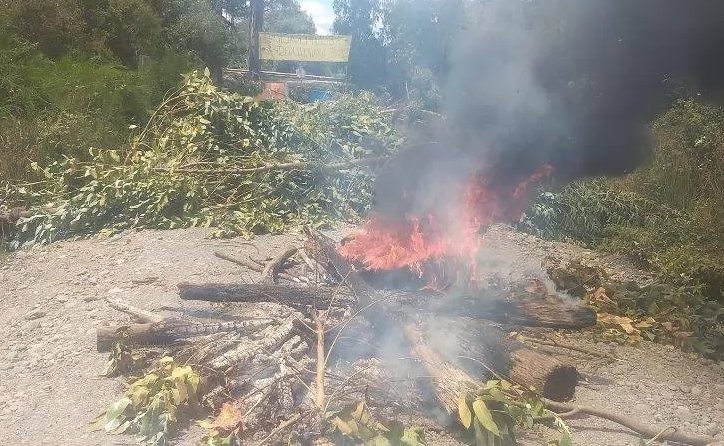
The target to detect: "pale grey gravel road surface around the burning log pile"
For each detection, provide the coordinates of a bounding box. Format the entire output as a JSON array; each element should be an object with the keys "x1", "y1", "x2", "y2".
[{"x1": 0, "y1": 227, "x2": 724, "y2": 446}]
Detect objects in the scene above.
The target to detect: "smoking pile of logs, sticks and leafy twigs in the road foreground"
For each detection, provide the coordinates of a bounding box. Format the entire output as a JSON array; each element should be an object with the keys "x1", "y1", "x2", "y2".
[{"x1": 97, "y1": 227, "x2": 710, "y2": 446}]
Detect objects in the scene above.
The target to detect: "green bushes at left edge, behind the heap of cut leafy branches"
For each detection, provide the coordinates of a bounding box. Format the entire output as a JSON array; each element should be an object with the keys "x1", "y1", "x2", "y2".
[{"x1": 0, "y1": 20, "x2": 190, "y2": 181}]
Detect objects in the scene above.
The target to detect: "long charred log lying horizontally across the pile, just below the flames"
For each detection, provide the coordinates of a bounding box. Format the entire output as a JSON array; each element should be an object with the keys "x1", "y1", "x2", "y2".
[{"x1": 178, "y1": 282, "x2": 596, "y2": 329}]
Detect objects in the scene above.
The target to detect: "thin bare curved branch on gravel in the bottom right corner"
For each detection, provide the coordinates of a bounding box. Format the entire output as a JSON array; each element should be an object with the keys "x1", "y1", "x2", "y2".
[{"x1": 543, "y1": 399, "x2": 717, "y2": 446}]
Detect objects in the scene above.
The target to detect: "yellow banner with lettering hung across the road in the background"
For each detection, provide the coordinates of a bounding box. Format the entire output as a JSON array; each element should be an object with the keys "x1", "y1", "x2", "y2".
[{"x1": 259, "y1": 33, "x2": 352, "y2": 62}]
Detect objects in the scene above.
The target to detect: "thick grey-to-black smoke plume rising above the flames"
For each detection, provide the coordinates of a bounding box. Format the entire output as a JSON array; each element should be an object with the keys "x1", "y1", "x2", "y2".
[{"x1": 377, "y1": 0, "x2": 724, "y2": 220}]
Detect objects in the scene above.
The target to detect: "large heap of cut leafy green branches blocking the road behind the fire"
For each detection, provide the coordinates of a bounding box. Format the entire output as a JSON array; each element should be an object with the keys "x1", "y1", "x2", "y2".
[{"x1": 2, "y1": 73, "x2": 397, "y2": 247}]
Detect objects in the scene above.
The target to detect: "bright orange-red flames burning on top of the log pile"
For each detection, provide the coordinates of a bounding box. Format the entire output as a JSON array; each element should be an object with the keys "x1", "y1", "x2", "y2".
[{"x1": 340, "y1": 165, "x2": 552, "y2": 283}]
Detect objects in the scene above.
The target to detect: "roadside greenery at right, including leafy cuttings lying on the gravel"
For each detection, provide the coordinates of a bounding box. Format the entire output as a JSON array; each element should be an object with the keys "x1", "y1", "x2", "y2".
[{"x1": 522, "y1": 100, "x2": 724, "y2": 357}]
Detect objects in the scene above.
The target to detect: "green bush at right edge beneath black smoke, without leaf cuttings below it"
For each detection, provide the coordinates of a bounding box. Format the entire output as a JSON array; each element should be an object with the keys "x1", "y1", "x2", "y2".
[{"x1": 522, "y1": 100, "x2": 724, "y2": 299}]
